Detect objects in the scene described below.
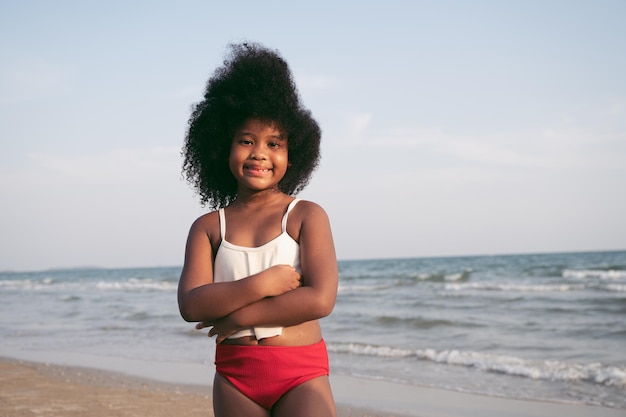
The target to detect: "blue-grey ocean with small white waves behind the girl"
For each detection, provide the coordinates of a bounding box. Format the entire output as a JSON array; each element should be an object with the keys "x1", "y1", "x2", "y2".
[{"x1": 0, "y1": 251, "x2": 626, "y2": 409}]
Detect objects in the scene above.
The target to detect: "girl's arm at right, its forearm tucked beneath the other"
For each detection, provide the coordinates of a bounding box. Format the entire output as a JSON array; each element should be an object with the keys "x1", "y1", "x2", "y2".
[{"x1": 217, "y1": 201, "x2": 338, "y2": 335}]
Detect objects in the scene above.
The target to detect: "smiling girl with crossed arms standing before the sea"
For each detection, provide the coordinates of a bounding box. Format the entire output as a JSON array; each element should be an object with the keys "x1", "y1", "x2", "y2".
[{"x1": 178, "y1": 44, "x2": 338, "y2": 417}]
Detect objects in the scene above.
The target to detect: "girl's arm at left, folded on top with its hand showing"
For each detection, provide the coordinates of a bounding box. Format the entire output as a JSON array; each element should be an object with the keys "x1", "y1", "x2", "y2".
[{"x1": 178, "y1": 213, "x2": 300, "y2": 322}]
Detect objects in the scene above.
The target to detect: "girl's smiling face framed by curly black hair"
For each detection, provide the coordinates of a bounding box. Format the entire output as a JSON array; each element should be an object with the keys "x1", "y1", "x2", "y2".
[{"x1": 228, "y1": 119, "x2": 289, "y2": 193}]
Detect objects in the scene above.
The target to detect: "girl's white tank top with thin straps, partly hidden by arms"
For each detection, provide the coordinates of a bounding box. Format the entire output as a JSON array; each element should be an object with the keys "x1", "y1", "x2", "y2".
[{"x1": 213, "y1": 199, "x2": 300, "y2": 340}]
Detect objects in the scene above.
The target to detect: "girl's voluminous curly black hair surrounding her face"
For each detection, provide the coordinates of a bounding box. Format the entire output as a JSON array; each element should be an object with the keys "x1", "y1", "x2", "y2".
[{"x1": 182, "y1": 43, "x2": 321, "y2": 209}]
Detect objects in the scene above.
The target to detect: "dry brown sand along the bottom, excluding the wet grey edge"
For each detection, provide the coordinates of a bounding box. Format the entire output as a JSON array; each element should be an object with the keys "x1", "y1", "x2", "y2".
[{"x1": 0, "y1": 359, "x2": 397, "y2": 417}]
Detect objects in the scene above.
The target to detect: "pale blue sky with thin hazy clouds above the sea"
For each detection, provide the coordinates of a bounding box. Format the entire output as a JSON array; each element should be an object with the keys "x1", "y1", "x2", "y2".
[{"x1": 0, "y1": 0, "x2": 626, "y2": 271}]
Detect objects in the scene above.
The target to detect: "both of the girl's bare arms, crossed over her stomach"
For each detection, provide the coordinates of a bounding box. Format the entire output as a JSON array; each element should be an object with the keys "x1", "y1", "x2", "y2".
[{"x1": 178, "y1": 202, "x2": 338, "y2": 342}]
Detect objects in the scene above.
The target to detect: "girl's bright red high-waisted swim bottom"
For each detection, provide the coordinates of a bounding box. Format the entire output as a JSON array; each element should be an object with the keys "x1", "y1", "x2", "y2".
[{"x1": 215, "y1": 339, "x2": 329, "y2": 410}]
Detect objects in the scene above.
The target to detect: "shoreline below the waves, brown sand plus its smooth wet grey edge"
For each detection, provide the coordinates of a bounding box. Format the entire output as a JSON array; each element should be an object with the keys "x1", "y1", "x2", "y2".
[{"x1": 0, "y1": 348, "x2": 625, "y2": 417}]
